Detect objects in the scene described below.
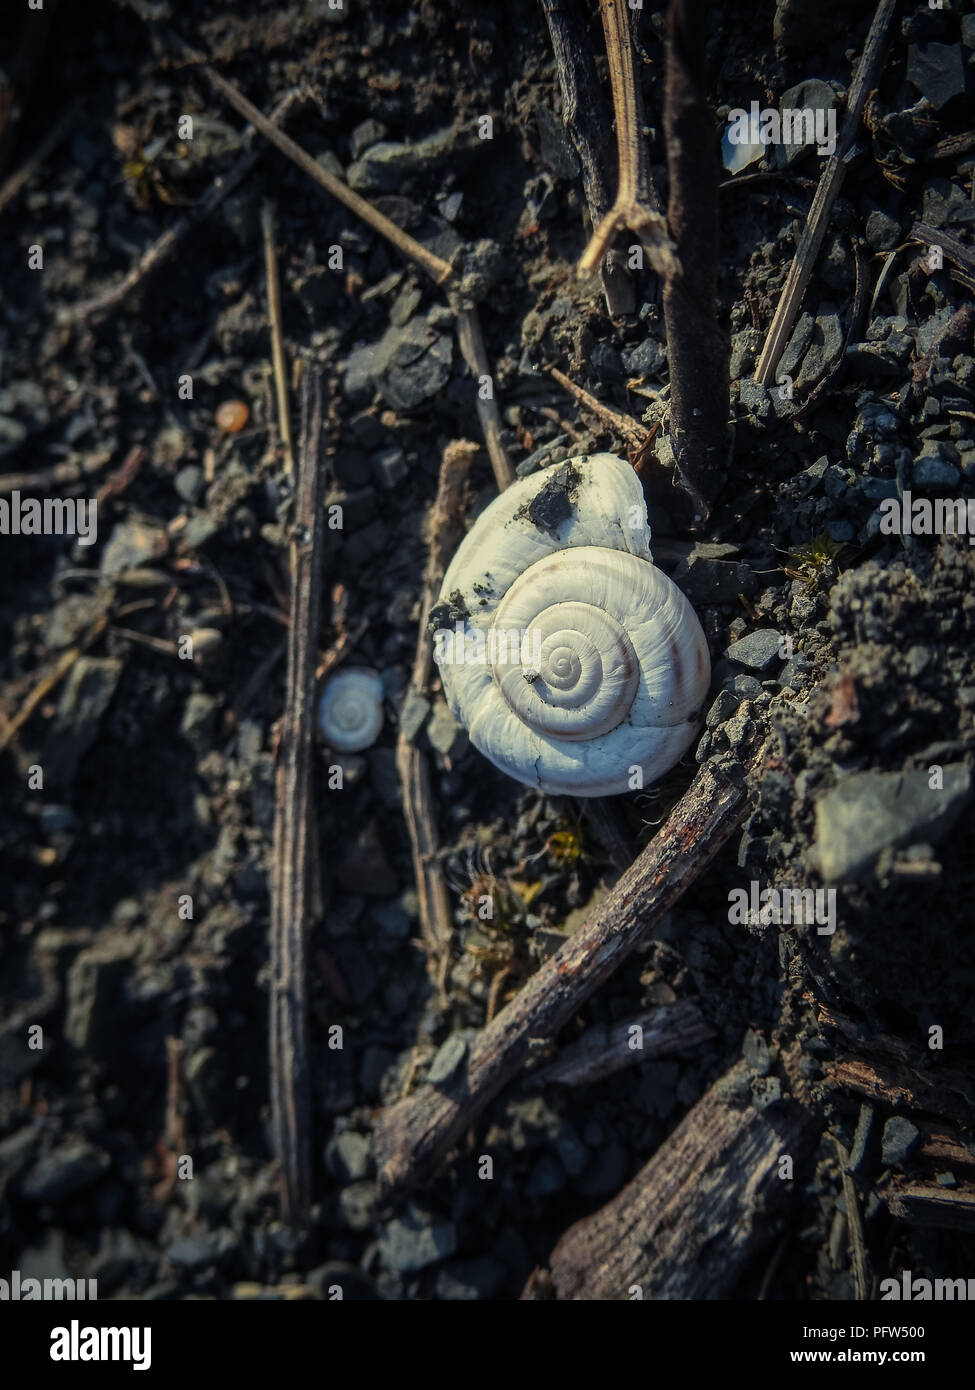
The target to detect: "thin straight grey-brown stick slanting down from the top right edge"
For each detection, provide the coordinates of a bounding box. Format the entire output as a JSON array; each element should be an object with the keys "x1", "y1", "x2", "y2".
[{"x1": 755, "y1": 0, "x2": 897, "y2": 386}]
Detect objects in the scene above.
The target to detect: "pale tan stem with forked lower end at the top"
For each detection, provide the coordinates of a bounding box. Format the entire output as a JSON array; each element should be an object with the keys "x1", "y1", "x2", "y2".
[{"x1": 579, "y1": 0, "x2": 676, "y2": 275}]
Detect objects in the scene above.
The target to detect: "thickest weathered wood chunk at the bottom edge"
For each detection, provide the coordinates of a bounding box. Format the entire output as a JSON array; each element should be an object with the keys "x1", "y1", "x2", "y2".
[{"x1": 536, "y1": 1062, "x2": 819, "y2": 1301}]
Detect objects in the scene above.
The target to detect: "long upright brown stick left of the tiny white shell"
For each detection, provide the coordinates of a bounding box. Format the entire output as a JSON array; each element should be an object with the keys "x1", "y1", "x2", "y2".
[{"x1": 270, "y1": 373, "x2": 325, "y2": 1225}]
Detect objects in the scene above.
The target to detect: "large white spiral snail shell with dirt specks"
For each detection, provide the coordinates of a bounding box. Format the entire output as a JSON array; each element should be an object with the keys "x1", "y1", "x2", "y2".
[{"x1": 431, "y1": 453, "x2": 711, "y2": 796}]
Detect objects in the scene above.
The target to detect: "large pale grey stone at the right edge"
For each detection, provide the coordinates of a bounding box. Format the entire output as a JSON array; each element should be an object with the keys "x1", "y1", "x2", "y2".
[{"x1": 815, "y1": 763, "x2": 972, "y2": 883}]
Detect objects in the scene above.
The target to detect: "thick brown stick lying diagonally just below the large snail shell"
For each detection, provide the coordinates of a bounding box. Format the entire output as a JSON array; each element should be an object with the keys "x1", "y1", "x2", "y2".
[{"x1": 376, "y1": 755, "x2": 761, "y2": 1193}]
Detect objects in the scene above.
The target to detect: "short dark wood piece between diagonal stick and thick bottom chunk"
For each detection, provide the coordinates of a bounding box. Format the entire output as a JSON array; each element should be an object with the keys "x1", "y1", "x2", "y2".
[{"x1": 531, "y1": 999, "x2": 714, "y2": 1086}]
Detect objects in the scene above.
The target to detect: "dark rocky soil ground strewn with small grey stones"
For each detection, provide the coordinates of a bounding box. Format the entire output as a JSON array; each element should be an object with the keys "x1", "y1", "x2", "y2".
[{"x1": 0, "y1": 0, "x2": 975, "y2": 1300}]
